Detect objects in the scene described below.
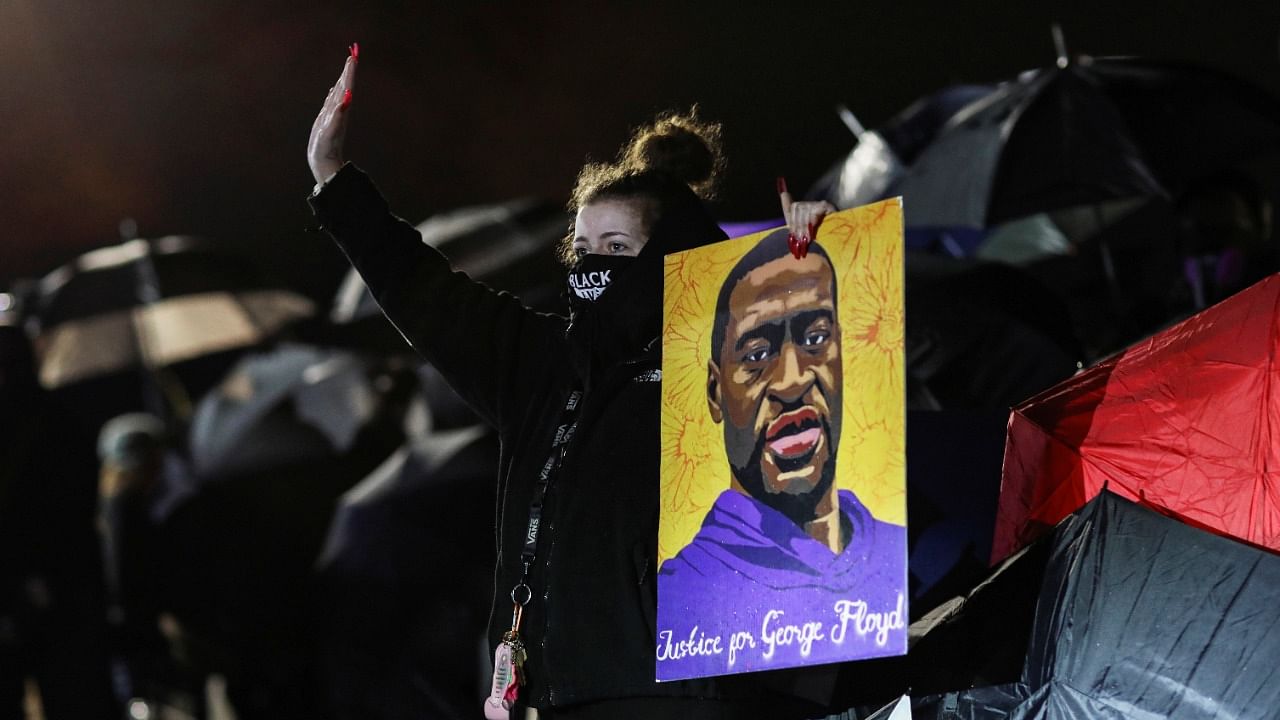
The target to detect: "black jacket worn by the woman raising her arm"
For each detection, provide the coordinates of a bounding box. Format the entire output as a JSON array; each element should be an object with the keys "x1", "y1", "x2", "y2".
[{"x1": 311, "y1": 164, "x2": 829, "y2": 707}]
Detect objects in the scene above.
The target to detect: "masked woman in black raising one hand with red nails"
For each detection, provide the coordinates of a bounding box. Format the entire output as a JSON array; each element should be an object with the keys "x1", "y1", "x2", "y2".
[{"x1": 307, "y1": 46, "x2": 829, "y2": 717}]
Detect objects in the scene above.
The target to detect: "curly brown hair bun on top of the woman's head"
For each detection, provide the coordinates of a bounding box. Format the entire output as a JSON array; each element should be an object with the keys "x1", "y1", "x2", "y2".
[{"x1": 617, "y1": 105, "x2": 724, "y2": 199}]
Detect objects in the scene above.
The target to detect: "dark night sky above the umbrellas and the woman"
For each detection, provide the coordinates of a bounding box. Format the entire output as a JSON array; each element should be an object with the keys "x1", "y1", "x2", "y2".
[{"x1": 0, "y1": 0, "x2": 1280, "y2": 297}]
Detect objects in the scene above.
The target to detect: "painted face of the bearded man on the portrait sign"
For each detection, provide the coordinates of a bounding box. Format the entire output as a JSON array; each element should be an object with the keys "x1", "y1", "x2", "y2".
[{"x1": 708, "y1": 254, "x2": 844, "y2": 521}]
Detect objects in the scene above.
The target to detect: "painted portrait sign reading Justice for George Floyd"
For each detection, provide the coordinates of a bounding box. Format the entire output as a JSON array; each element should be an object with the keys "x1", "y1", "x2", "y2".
[{"x1": 657, "y1": 199, "x2": 908, "y2": 680}]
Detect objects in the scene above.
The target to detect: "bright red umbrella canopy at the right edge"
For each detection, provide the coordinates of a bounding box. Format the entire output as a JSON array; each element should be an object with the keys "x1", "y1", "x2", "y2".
[{"x1": 992, "y1": 269, "x2": 1280, "y2": 560}]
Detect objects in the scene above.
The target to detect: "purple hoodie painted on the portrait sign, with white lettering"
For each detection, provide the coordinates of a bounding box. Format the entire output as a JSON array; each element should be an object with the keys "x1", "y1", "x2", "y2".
[{"x1": 657, "y1": 489, "x2": 908, "y2": 680}]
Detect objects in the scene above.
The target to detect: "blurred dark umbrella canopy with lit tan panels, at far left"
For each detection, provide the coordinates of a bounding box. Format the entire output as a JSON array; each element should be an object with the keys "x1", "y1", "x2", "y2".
[{"x1": 33, "y1": 236, "x2": 314, "y2": 388}]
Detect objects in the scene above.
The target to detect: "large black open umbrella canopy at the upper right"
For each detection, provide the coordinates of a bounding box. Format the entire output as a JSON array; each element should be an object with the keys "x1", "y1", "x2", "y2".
[{"x1": 888, "y1": 58, "x2": 1280, "y2": 228}]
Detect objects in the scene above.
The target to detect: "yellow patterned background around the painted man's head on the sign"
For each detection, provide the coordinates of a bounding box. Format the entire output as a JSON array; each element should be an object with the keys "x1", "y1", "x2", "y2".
[{"x1": 658, "y1": 199, "x2": 906, "y2": 564}]
